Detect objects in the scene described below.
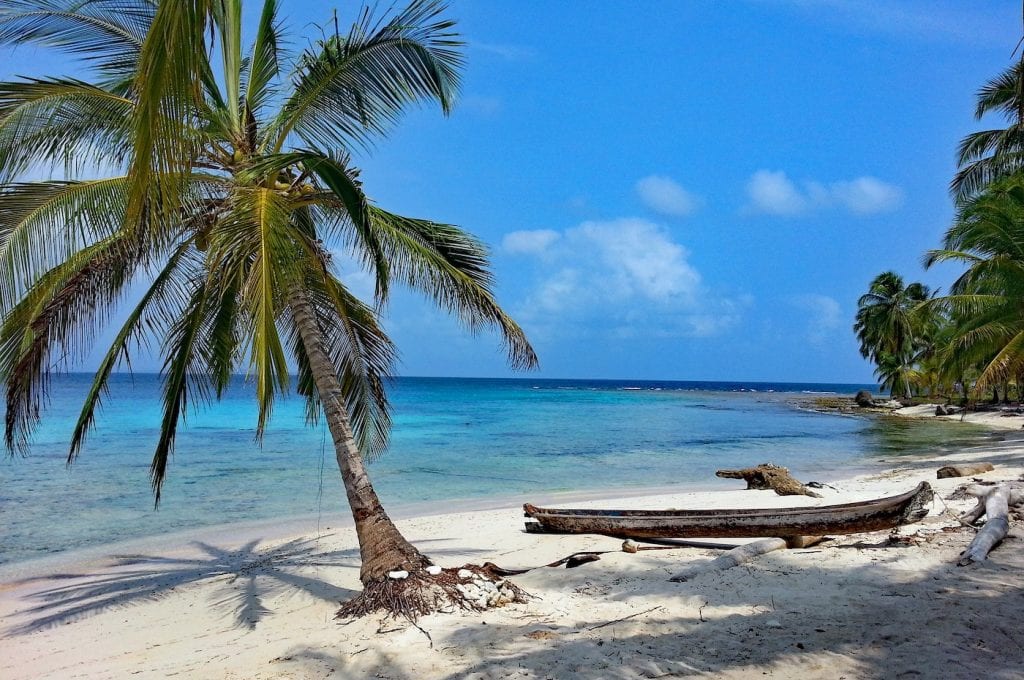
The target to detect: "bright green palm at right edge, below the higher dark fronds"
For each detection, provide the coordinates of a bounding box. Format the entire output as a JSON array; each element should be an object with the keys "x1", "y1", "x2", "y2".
[{"x1": 926, "y1": 175, "x2": 1024, "y2": 390}]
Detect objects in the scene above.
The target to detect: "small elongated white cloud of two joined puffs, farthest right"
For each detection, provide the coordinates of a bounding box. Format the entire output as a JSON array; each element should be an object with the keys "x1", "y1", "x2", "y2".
[{"x1": 746, "y1": 170, "x2": 903, "y2": 215}]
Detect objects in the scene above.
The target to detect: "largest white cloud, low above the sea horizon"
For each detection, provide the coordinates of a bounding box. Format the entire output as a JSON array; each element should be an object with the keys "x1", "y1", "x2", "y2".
[{"x1": 506, "y1": 218, "x2": 748, "y2": 340}]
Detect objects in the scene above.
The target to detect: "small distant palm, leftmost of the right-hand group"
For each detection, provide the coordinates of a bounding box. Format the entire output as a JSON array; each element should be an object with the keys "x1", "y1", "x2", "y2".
[{"x1": 853, "y1": 271, "x2": 932, "y2": 397}]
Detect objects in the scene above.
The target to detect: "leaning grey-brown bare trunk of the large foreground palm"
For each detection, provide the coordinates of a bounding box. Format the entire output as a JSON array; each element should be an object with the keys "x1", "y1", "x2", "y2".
[{"x1": 289, "y1": 291, "x2": 430, "y2": 585}]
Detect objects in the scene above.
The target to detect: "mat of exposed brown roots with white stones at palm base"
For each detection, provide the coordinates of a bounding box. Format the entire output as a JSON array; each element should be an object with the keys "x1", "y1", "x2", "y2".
[{"x1": 335, "y1": 564, "x2": 529, "y2": 623}]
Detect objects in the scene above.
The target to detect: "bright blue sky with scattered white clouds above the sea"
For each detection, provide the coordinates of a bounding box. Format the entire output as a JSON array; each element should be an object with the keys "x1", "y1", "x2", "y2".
[{"x1": 0, "y1": 0, "x2": 1021, "y2": 382}]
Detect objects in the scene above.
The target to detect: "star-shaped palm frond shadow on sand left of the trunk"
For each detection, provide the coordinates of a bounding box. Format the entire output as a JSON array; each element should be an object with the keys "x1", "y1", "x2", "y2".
[{"x1": 6, "y1": 539, "x2": 359, "y2": 635}]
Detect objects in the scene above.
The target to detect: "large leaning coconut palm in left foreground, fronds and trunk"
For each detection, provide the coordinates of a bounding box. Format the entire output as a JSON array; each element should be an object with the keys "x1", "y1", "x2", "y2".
[{"x1": 0, "y1": 0, "x2": 537, "y2": 614}]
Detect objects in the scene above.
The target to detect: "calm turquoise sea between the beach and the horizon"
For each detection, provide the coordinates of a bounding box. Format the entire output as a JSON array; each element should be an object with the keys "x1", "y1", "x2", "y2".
[{"x1": 0, "y1": 375, "x2": 991, "y2": 564}]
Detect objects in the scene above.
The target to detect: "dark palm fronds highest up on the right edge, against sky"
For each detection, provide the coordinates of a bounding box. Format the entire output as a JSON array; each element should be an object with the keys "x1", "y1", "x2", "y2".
[{"x1": 949, "y1": 60, "x2": 1024, "y2": 203}]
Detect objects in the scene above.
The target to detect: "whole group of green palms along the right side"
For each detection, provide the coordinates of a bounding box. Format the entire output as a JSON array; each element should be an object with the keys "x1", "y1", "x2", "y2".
[{"x1": 853, "y1": 55, "x2": 1024, "y2": 400}]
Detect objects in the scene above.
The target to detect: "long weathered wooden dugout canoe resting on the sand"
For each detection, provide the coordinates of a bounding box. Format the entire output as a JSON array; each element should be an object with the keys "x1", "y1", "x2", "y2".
[{"x1": 522, "y1": 481, "x2": 933, "y2": 539}]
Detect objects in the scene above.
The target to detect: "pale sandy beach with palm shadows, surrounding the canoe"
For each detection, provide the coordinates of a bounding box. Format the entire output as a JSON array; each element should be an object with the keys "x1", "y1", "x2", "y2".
[{"x1": 0, "y1": 435, "x2": 1024, "y2": 680}]
